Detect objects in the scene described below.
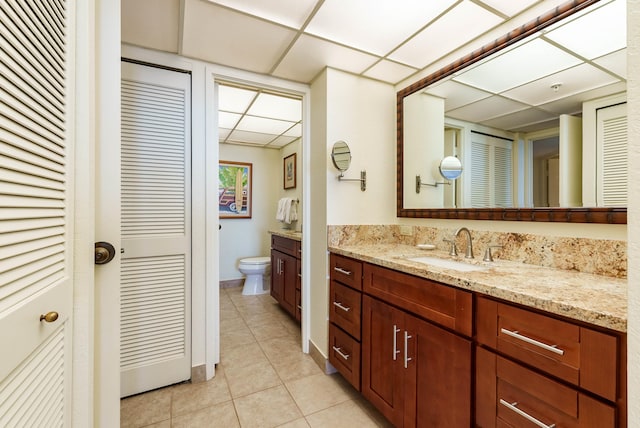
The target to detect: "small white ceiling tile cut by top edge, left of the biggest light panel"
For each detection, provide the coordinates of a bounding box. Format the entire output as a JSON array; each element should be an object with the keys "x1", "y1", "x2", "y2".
[{"x1": 204, "y1": 0, "x2": 316, "y2": 28}]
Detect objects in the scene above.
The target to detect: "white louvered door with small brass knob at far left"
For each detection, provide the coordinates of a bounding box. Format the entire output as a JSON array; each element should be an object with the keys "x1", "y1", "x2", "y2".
[{"x1": 0, "y1": 0, "x2": 73, "y2": 427}]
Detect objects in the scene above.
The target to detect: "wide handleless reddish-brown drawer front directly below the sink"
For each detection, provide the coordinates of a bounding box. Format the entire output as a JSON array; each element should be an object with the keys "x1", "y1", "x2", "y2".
[{"x1": 363, "y1": 264, "x2": 473, "y2": 337}]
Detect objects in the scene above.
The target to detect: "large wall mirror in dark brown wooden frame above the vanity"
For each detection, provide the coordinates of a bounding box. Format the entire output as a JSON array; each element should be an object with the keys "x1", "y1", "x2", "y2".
[{"x1": 397, "y1": 0, "x2": 627, "y2": 223}]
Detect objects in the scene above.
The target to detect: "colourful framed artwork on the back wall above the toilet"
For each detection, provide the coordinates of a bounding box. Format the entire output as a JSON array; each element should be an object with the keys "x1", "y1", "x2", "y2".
[{"x1": 218, "y1": 160, "x2": 253, "y2": 218}]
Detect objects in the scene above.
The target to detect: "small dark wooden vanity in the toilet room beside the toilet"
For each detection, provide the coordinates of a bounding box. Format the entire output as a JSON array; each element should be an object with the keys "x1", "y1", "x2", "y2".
[{"x1": 271, "y1": 232, "x2": 302, "y2": 322}]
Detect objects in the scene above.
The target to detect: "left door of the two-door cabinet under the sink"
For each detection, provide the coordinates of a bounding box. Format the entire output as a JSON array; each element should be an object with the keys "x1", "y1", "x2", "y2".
[{"x1": 362, "y1": 296, "x2": 404, "y2": 426}]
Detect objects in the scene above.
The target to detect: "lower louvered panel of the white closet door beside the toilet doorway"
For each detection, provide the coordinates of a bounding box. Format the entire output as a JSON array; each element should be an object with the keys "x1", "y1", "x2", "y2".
[{"x1": 120, "y1": 255, "x2": 187, "y2": 369}]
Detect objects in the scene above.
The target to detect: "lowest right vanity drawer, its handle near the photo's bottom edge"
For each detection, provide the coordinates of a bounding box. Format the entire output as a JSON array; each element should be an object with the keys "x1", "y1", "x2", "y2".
[{"x1": 476, "y1": 349, "x2": 616, "y2": 428}]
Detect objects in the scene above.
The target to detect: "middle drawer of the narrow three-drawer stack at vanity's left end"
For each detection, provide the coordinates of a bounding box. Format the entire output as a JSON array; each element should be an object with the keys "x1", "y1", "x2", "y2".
[{"x1": 329, "y1": 281, "x2": 362, "y2": 340}]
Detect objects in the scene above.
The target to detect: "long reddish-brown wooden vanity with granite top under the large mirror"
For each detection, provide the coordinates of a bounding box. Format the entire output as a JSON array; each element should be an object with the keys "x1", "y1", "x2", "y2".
[{"x1": 329, "y1": 244, "x2": 626, "y2": 427}]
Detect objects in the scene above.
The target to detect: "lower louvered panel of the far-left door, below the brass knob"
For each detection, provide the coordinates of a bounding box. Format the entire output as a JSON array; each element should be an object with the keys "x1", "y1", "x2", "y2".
[{"x1": 0, "y1": 328, "x2": 66, "y2": 427}]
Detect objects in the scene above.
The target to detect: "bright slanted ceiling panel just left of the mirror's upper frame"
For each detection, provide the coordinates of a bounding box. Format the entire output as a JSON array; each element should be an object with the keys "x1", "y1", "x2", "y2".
[{"x1": 389, "y1": 1, "x2": 503, "y2": 68}]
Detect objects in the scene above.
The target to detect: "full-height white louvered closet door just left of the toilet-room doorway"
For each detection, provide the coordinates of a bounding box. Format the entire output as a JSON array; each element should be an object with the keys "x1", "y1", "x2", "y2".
[{"x1": 120, "y1": 62, "x2": 191, "y2": 397}]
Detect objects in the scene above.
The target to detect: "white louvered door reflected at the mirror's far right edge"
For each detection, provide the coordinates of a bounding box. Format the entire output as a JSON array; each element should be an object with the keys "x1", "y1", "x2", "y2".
[{"x1": 596, "y1": 103, "x2": 628, "y2": 207}]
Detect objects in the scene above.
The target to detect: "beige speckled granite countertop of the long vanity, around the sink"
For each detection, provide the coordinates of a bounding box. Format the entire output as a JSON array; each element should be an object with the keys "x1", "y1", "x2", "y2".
[{"x1": 329, "y1": 244, "x2": 627, "y2": 332}]
